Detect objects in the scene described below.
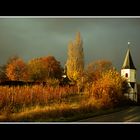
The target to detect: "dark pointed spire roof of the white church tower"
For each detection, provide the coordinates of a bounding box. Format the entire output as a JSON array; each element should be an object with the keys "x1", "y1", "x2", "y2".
[{"x1": 122, "y1": 49, "x2": 136, "y2": 69}]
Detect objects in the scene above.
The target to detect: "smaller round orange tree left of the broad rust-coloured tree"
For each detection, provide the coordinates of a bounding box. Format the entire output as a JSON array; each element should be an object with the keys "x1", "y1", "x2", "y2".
[{"x1": 6, "y1": 57, "x2": 28, "y2": 81}]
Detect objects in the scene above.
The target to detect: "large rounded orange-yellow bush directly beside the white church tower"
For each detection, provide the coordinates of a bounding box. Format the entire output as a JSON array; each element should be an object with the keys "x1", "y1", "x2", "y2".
[{"x1": 88, "y1": 69, "x2": 129, "y2": 108}]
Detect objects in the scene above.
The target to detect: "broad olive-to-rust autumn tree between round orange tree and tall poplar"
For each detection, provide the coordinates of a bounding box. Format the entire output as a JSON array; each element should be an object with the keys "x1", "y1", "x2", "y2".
[{"x1": 28, "y1": 56, "x2": 62, "y2": 81}]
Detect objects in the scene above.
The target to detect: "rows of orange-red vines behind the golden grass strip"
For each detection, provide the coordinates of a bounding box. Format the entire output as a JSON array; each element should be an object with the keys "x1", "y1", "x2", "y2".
[{"x1": 0, "y1": 85, "x2": 77, "y2": 112}]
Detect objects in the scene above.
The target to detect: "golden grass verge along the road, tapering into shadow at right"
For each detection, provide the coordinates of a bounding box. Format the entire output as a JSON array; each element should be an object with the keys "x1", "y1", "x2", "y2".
[{"x1": 0, "y1": 98, "x2": 129, "y2": 122}]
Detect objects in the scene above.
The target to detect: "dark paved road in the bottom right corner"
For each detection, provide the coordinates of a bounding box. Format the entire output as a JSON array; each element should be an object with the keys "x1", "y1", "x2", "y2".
[{"x1": 80, "y1": 106, "x2": 140, "y2": 122}]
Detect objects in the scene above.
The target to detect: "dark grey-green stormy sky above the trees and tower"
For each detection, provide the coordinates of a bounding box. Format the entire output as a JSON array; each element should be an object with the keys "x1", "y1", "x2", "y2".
[{"x1": 0, "y1": 17, "x2": 140, "y2": 81}]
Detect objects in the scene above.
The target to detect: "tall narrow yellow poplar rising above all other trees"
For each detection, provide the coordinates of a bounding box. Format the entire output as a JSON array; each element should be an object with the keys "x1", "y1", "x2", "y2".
[{"x1": 66, "y1": 32, "x2": 84, "y2": 82}]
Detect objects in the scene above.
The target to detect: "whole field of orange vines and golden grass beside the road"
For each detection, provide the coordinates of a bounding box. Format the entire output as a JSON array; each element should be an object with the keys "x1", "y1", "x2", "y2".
[{"x1": 0, "y1": 86, "x2": 129, "y2": 122}]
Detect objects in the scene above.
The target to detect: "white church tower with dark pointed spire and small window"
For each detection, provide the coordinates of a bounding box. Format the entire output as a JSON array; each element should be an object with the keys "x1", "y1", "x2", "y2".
[{"x1": 121, "y1": 44, "x2": 137, "y2": 102}]
